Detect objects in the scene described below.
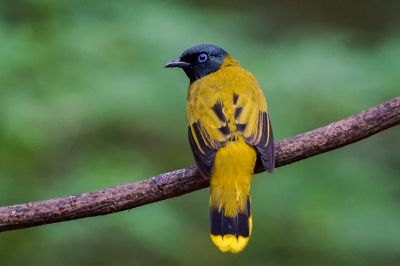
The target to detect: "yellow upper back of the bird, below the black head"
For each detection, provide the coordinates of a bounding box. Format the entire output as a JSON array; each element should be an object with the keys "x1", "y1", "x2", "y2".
[{"x1": 187, "y1": 56, "x2": 267, "y2": 144}]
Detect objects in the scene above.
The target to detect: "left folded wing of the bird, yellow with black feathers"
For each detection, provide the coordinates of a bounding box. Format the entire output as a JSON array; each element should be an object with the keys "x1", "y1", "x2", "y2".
[{"x1": 187, "y1": 98, "x2": 231, "y2": 176}]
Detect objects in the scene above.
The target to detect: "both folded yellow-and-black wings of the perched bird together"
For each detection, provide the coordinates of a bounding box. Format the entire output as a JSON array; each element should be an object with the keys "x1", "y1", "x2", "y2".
[{"x1": 187, "y1": 70, "x2": 275, "y2": 176}]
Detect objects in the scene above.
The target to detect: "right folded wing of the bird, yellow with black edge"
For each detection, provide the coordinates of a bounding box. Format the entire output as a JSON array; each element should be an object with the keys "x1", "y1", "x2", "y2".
[{"x1": 234, "y1": 82, "x2": 275, "y2": 172}]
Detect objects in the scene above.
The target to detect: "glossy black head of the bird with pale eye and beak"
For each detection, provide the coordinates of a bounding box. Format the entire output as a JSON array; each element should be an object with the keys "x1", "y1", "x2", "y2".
[{"x1": 165, "y1": 44, "x2": 228, "y2": 82}]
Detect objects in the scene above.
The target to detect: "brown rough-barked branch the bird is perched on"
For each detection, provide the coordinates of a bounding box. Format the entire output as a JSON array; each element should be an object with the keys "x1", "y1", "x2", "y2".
[{"x1": 0, "y1": 97, "x2": 400, "y2": 231}]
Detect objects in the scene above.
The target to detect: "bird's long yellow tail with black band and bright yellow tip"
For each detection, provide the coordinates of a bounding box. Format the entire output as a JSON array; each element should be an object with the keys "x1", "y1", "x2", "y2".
[{"x1": 210, "y1": 141, "x2": 256, "y2": 253}]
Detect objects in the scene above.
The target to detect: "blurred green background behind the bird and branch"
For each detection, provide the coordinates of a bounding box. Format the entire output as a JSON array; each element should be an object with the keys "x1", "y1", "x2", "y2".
[{"x1": 0, "y1": 0, "x2": 400, "y2": 266}]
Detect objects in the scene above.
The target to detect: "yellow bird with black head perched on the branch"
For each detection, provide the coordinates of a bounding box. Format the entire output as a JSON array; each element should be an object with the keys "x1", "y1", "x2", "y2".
[{"x1": 164, "y1": 44, "x2": 275, "y2": 253}]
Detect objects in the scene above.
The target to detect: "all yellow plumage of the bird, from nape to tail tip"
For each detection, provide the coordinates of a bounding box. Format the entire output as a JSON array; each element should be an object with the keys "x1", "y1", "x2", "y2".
[{"x1": 187, "y1": 55, "x2": 269, "y2": 253}]
